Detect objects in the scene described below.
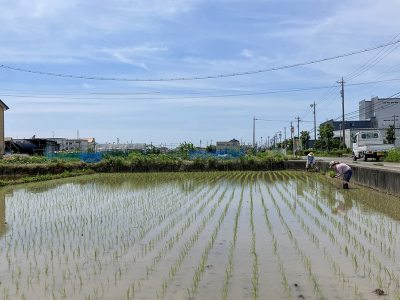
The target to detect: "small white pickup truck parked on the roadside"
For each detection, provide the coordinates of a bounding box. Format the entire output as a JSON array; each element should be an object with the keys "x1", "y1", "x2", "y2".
[{"x1": 353, "y1": 131, "x2": 394, "y2": 161}]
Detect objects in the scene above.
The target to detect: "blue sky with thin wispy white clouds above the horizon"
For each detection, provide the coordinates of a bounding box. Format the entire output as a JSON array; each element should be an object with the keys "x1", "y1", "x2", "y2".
[{"x1": 0, "y1": 0, "x2": 400, "y2": 146}]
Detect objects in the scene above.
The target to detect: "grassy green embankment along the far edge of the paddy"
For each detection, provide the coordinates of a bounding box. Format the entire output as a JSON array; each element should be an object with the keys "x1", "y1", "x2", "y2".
[{"x1": 0, "y1": 152, "x2": 296, "y2": 186}]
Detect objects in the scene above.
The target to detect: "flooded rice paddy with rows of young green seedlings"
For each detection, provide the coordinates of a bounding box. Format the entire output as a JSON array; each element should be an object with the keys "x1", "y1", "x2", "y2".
[{"x1": 0, "y1": 171, "x2": 400, "y2": 300}]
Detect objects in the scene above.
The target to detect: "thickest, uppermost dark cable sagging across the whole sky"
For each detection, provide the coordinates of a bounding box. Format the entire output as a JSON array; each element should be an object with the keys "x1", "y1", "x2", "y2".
[{"x1": 0, "y1": 40, "x2": 400, "y2": 82}]
